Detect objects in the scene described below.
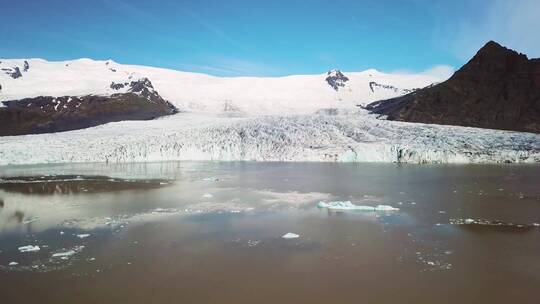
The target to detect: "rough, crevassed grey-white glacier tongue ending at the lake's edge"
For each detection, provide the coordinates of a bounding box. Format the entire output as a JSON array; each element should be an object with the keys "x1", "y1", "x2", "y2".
[{"x1": 0, "y1": 112, "x2": 540, "y2": 165}]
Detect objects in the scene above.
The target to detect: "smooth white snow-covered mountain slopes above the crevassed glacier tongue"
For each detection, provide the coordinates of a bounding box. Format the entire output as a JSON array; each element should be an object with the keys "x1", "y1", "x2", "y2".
[{"x1": 0, "y1": 59, "x2": 438, "y2": 115}]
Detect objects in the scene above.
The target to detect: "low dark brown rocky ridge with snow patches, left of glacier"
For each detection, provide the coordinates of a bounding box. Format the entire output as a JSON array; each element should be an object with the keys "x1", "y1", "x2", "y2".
[{"x1": 0, "y1": 78, "x2": 177, "y2": 136}]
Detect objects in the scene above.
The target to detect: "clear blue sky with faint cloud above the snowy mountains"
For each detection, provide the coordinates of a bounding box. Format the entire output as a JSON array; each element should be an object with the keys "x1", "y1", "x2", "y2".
[{"x1": 0, "y1": 0, "x2": 540, "y2": 76}]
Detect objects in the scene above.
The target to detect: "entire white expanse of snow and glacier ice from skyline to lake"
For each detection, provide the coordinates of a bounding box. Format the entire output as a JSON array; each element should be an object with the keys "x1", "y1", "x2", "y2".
[{"x1": 0, "y1": 59, "x2": 540, "y2": 165}]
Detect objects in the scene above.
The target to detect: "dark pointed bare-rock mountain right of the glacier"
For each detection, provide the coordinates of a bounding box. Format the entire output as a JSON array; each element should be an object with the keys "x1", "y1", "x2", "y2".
[{"x1": 367, "y1": 41, "x2": 540, "y2": 133}]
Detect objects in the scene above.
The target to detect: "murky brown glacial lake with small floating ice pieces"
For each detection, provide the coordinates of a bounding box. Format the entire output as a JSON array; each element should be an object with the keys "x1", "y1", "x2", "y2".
[{"x1": 0, "y1": 162, "x2": 540, "y2": 304}]
